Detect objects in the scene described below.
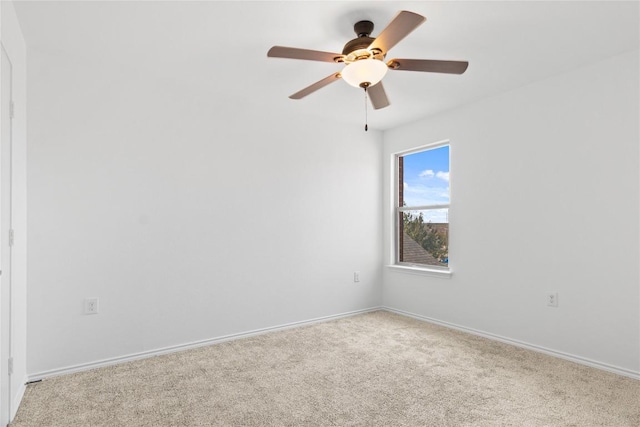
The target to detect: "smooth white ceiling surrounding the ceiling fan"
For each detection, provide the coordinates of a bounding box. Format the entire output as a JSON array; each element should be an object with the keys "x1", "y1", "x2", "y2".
[{"x1": 11, "y1": 1, "x2": 640, "y2": 129}]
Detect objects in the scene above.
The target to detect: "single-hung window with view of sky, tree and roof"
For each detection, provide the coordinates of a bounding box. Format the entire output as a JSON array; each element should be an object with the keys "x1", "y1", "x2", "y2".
[{"x1": 395, "y1": 143, "x2": 450, "y2": 271}]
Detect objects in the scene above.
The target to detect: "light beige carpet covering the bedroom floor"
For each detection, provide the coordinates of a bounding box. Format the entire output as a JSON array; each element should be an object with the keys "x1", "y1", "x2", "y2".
[{"x1": 12, "y1": 311, "x2": 640, "y2": 427}]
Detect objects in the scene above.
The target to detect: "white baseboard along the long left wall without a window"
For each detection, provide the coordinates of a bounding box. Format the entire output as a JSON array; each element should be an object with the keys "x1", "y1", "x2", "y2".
[{"x1": 23, "y1": 307, "x2": 382, "y2": 382}]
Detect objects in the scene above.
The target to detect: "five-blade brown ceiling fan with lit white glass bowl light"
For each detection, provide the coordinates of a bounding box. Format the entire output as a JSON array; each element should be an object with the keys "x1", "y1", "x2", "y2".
[{"x1": 267, "y1": 10, "x2": 469, "y2": 110}]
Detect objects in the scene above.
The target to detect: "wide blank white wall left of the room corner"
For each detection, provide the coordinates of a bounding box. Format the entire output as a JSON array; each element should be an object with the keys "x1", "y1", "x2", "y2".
[{"x1": 28, "y1": 49, "x2": 382, "y2": 376}]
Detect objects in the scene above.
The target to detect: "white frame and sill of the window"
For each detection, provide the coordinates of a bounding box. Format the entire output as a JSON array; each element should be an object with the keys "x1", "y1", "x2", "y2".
[{"x1": 388, "y1": 140, "x2": 452, "y2": 278}]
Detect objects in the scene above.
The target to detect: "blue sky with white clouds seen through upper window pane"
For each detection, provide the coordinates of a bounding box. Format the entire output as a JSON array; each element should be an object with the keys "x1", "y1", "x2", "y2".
[{"x1": 403, "y1": 146, "x2": 449, "y2": 216}]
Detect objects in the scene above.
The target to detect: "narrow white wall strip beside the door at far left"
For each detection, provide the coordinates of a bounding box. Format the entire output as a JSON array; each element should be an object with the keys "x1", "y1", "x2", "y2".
[{"x1": 0, "y1": 1, "x2": 27, "y2": 422}]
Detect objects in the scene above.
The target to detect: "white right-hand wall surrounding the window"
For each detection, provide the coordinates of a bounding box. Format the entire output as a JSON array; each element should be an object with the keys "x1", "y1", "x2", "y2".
[{"x1": 383, "y1": 52, "x2": 640, "y2": 375}]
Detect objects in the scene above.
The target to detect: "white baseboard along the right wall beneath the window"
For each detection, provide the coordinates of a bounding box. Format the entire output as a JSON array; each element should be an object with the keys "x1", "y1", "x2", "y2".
[{"x1": 382, "y1": 306, "x2": 640, "y2": 380}]
